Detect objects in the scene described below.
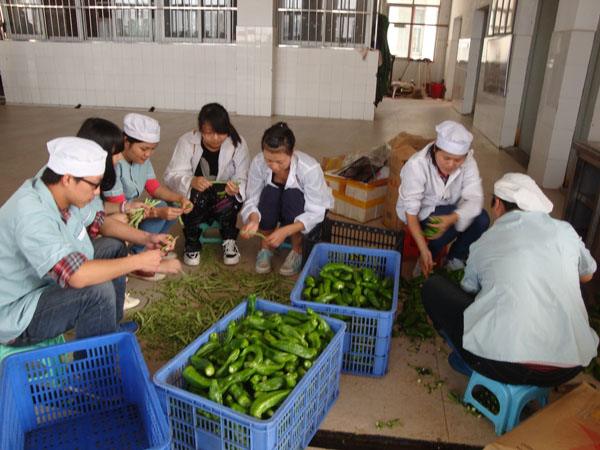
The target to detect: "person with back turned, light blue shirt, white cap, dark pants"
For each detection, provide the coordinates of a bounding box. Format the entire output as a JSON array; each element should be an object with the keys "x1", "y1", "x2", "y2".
[{"x1": 422, "y1": 173, "x2": 598, "y2": 386}]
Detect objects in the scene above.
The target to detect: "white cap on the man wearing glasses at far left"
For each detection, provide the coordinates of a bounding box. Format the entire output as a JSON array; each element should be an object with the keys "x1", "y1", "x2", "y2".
[{"x1": 46, "y1": 137, "x2": 107, "y2": 177}]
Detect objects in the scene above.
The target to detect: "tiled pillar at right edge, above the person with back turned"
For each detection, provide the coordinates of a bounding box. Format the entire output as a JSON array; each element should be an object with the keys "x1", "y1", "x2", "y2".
[{"x1": 527, "y1": 0, "x2": 600, "y2": 189}]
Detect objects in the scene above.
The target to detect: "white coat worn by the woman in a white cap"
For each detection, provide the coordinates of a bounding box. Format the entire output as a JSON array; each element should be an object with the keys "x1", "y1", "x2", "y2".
[{"x1": 396, "y1": 142, "x2": 483, "y2": 232}]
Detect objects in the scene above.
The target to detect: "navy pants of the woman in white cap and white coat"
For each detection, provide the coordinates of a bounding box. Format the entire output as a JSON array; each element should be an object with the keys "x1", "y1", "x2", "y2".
[{"x1": 421, "y1": 205, "x2": 490, "y2": 261}]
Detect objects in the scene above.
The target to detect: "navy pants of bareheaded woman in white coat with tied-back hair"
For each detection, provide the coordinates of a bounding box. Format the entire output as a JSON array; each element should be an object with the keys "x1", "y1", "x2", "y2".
[{"x1": 258, "y1": 185, "x2": 304, "y2": 231}]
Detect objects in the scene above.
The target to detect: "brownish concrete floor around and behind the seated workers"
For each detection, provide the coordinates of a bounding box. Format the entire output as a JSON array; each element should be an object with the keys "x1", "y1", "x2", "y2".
[{"x1": 0, "y1": 98, "x2": 593, "y2": 448}]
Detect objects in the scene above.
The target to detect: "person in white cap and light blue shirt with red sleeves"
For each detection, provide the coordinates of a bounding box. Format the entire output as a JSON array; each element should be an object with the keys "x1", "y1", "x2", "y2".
[{"x1": 103, "y1": 113, "x2": 194, "y2": 281}]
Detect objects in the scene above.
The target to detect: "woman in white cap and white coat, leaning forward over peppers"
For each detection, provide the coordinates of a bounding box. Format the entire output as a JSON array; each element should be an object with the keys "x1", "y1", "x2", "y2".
[{"x1": 396, "y1": 120, "x2": 490, "y2": 276}]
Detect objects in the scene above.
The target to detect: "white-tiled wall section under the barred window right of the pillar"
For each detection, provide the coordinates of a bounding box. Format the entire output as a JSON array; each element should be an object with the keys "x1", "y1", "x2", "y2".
[{"x1": 273, "y1": 47, "x2": 379, "y2": 120}]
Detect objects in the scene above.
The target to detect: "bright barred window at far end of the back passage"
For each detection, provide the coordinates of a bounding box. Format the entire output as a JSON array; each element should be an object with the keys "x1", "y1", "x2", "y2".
[{"x1": 387, "y1": 0, "x2": 440, "y2": 61}]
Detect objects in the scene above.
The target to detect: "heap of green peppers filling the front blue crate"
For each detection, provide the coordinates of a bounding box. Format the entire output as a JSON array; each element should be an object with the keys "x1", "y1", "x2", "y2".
[{"x1": 182, "y1": 296, "x2": 334, "y2": 420}]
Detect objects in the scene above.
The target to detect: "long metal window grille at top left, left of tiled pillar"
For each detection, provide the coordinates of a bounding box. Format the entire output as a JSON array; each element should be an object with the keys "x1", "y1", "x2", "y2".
[{"x1": 0, "y1": 0, "x2": 237, "y2": 43}]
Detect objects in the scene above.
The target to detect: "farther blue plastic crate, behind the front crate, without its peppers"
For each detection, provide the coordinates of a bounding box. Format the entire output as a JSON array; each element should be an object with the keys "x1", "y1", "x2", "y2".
[{"x1": 291, "y1": 243, "x2": 402, "y2": 377}]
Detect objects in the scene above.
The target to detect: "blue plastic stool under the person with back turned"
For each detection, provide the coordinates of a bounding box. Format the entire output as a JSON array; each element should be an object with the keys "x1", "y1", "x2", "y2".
[{"x1": 463, "y1": 371, "x2": 550, "y2": 436}]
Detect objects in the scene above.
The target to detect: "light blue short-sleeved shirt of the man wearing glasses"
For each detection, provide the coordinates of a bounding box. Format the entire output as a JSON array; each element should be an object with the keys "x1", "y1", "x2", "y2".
[{"x1": 0, "y1": 178, "x2": 94, "y2": 343}]
